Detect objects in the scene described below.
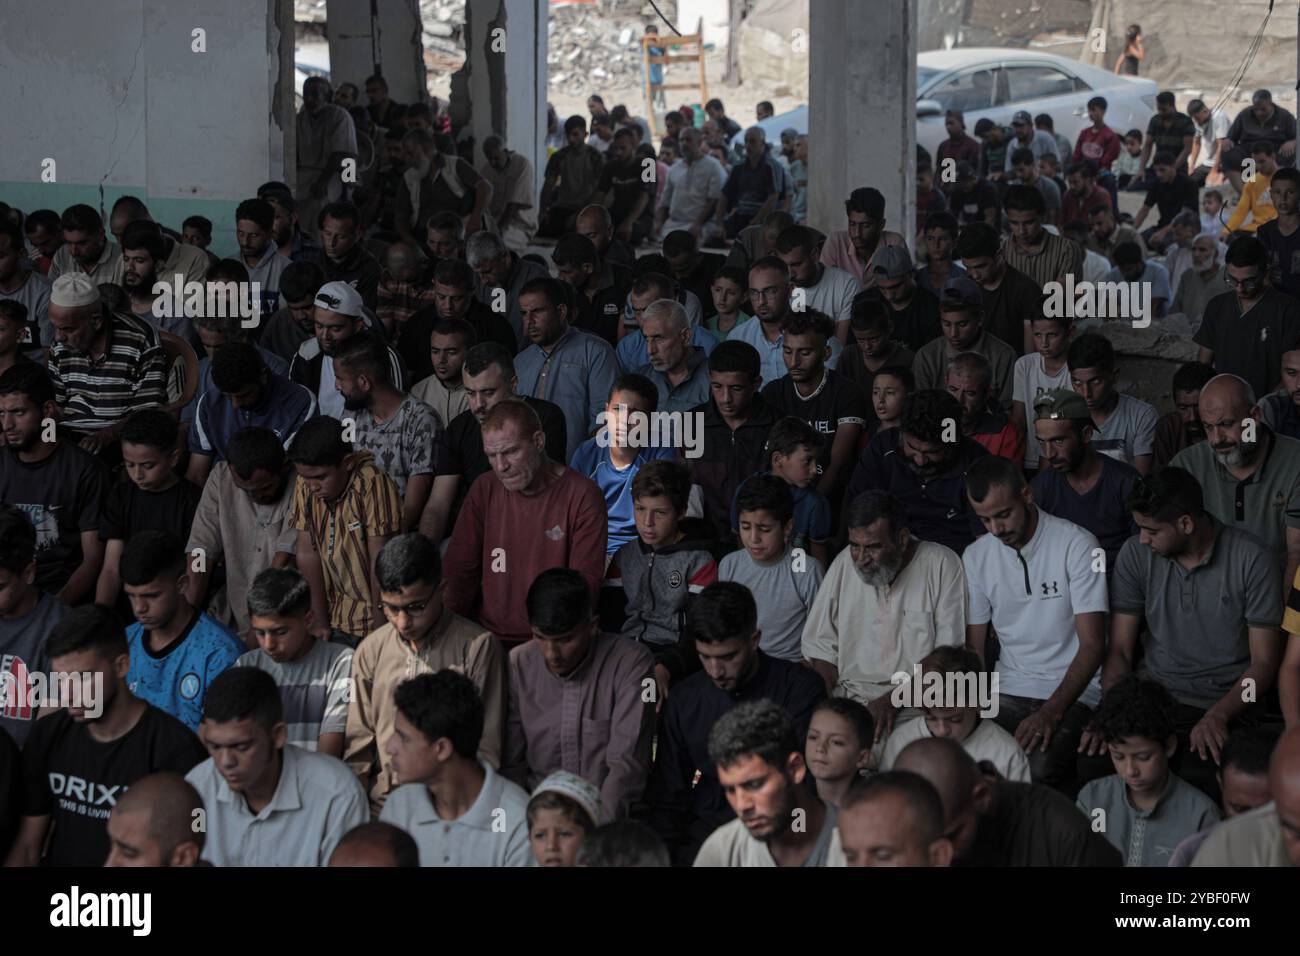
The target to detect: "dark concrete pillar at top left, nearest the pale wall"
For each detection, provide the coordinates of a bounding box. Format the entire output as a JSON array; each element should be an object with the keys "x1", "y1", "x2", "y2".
[{"x1": 325, "y1": 0, "x2": 426, "y2": 104}]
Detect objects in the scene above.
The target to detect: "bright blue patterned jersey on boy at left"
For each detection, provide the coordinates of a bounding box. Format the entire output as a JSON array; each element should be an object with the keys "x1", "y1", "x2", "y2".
[{"x1": 126, "y1": 614, "x2": 248, "y2": 734}]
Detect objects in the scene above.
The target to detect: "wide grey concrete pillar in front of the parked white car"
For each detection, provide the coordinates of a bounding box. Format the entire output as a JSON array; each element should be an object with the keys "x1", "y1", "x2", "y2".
[{"x1": 809, "y1": 0, "x2": 917, "y2": 246}]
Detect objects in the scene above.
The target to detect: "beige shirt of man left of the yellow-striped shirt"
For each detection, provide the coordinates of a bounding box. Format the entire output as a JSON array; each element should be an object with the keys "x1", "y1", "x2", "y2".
[{"x1": 186, "y1": 462, "x2": 298, "y2": 633}]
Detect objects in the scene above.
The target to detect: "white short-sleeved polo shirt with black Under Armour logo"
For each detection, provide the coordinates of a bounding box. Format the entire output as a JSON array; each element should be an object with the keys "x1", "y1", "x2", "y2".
[{"x1": 962, "y1": 509, "x2": 1109, "y2": 706}]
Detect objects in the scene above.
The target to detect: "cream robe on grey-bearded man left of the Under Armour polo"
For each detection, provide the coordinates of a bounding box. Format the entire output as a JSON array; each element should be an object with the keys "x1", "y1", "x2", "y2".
[{"x1": 803, "y1": 541, "x2": 966, "y2": 704}]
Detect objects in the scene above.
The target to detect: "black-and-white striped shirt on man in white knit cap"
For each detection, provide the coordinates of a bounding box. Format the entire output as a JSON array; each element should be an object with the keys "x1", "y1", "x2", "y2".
[{"x1": 49, "y1": 313, "x2": 168, "y2": 432}]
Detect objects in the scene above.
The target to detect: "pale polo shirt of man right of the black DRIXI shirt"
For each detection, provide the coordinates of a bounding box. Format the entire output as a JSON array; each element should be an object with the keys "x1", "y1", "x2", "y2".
[{"x1": 185, "y1": 747, "x2": 371, "y2": 866}]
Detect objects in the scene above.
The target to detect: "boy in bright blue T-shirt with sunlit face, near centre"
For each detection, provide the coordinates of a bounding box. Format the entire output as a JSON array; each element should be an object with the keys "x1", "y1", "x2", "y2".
[{"x1": 569, "y1": 372, "x2": 677, "y2": 557}]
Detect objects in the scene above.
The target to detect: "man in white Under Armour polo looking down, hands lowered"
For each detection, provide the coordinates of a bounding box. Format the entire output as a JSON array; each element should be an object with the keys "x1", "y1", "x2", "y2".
[{"x1": 962, "y1": 457, "x2": 1108, "y2": 795}]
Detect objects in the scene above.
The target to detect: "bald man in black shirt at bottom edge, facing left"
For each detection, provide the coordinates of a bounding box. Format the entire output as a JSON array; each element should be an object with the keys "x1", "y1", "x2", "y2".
[{"x1": 894, "y1": 737, "x2": 1122, "y2": 866}]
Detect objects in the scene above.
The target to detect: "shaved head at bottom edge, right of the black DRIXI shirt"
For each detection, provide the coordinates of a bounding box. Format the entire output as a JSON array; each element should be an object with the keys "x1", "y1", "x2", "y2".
[{"x1": 104, "y1": 774, "x2": 207, "y2": 866}]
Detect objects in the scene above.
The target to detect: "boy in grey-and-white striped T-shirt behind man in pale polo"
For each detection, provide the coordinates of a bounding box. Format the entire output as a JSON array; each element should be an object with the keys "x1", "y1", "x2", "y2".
[{"x1": 235, "y1": 567, "x2": 352, "y2": 757}]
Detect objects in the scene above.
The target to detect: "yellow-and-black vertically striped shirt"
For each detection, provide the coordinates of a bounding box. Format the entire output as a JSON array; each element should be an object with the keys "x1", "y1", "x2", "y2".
[{"x1": 287, "y1": 451, "x2": 402, "y2": 637}]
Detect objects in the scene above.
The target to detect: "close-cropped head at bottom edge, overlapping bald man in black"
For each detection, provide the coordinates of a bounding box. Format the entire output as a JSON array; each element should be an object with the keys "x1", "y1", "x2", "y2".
[{"x1": 837, "y1": 770, "x2": 953, "y2": 866}]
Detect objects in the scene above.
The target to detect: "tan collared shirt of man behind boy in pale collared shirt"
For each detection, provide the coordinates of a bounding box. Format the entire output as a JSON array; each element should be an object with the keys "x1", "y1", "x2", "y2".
[{"x1": 343, "y1": 609, "x2": 506, "y2": 813}]
